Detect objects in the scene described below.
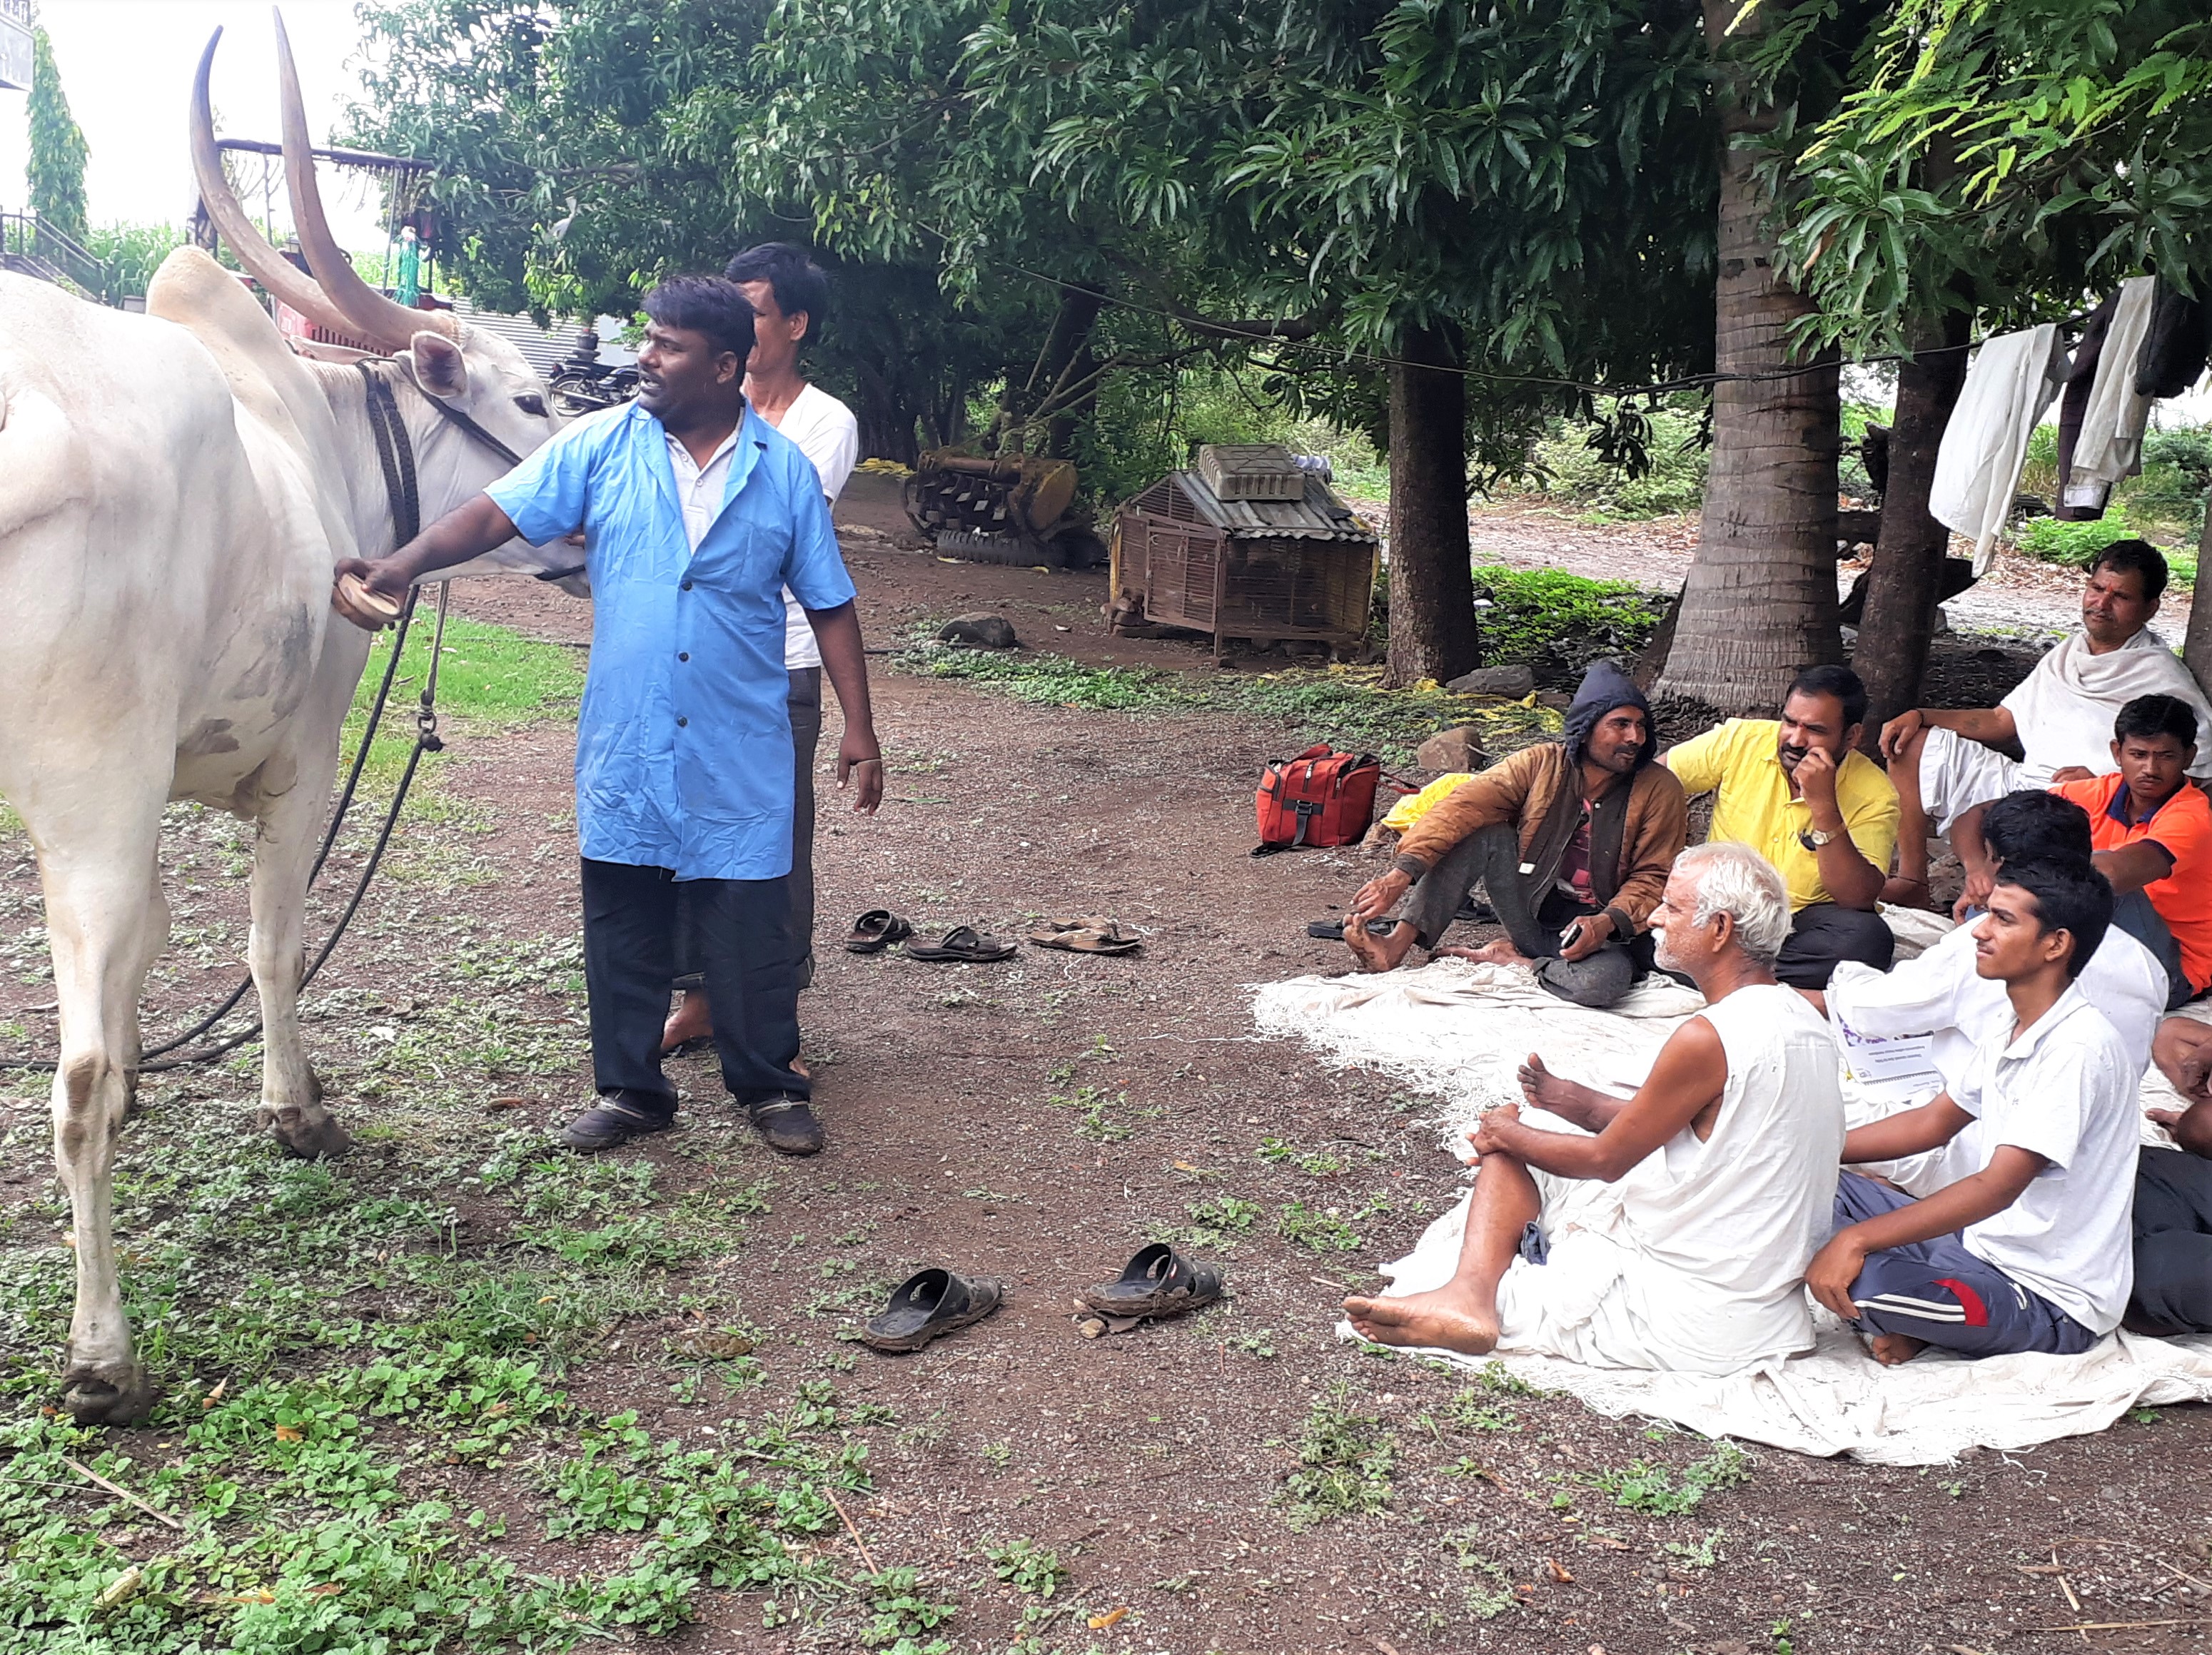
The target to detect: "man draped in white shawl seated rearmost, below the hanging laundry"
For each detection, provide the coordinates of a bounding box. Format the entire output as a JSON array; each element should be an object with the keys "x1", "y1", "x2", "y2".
[{"x1": 1882, "y1": 540, "x2": 2212, "y2": 905}]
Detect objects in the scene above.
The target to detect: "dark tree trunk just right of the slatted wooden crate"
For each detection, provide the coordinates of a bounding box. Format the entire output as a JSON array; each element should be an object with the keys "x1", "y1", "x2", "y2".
[{"x1": 1383, "y1": 328, "x2": 1482, "y2": 686}]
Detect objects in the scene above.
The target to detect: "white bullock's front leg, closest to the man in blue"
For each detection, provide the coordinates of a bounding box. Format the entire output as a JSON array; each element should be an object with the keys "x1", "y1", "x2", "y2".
[{"x1": 246, "y1": 766, "x2": 354, "y2": 1160}]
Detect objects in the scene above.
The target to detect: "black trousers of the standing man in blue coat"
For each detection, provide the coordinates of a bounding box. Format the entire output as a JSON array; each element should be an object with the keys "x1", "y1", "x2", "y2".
[{"x1": 584, "y1": 856, "x2": 809, "y2": 1115}]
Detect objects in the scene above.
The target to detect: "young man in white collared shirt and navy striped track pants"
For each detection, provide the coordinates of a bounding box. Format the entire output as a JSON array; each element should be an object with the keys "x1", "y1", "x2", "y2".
[{"x1": 1805, "y1": 861, "x2": 2141, "y2": 1363}]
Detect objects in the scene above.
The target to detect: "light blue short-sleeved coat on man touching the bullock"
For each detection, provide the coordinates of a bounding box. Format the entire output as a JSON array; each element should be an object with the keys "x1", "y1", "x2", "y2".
[{"x1": 485, "y1": 403, "x2": 854, "y2": 879}]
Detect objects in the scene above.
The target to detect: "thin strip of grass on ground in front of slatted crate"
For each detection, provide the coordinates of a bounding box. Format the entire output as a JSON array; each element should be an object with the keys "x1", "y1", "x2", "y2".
[{"x1": 896, "y1": 644, "x2": 1560, "y2": 764}]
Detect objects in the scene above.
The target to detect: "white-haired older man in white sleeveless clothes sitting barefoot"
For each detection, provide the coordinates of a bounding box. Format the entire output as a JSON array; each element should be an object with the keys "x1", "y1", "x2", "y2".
[{"x1": 1345, "y1": 843, "x2": 1842, "y2": 1374}]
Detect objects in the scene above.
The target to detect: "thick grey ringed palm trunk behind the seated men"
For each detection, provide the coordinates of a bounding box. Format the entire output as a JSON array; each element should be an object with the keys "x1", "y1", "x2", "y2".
[{"x1": 1659, "y1": 0, "x2": 1842, "y2": 714}]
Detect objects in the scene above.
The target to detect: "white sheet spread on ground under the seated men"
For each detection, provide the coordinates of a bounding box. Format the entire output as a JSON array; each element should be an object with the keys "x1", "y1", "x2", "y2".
[{"x1": 1254, "y1": 942, "x2": 2212, "y2": 1464}]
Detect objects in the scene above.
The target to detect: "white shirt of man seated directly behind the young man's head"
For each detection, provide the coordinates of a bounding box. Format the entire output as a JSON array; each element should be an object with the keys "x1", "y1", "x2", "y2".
[{"x1": 1827, "y1": 925, "x2": 2166, "y2": 1098}]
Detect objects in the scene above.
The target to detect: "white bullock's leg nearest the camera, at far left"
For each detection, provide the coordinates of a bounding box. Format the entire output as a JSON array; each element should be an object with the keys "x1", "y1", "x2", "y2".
[{"x1": 24, "y1": 814, "x2": 168, "y2": 1425}]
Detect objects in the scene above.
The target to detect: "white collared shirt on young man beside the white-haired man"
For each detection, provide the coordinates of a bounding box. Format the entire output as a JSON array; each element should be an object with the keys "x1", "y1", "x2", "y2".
[{"x1": 1951, "y1": 983, "x2": 2141, "y2": 1334}]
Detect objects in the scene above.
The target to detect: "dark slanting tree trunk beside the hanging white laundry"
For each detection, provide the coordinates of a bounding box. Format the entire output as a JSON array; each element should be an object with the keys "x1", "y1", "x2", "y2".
[{"x1": 1854, "y1": 310, "x2": 1971, "y2": 752}]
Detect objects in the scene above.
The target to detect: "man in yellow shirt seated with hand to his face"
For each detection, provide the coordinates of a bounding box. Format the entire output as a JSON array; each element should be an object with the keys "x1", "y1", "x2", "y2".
[{"x1": 1659, "y1": 666, "x2": 1898, "y2": 989}]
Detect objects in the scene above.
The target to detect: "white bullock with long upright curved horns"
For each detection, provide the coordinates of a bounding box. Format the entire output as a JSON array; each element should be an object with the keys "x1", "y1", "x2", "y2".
[{"x1": 0, "y1": 24, "x2": 575, "y2": 1422}]
